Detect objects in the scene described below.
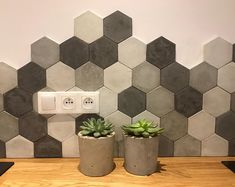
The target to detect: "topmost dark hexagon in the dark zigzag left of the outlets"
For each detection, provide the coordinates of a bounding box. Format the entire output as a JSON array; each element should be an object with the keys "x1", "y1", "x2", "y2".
[{"x1": 18, "y1": 62, "x2": 46, "y2": 93}]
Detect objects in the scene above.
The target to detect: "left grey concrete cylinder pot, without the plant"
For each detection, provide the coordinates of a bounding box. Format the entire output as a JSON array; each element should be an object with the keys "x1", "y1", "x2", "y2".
[{"x1": 78, "y1": 133, "x2": 115, "y2": 177}]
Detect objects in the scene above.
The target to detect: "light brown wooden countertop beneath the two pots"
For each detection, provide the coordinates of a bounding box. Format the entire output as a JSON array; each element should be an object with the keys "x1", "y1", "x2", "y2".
[{"x1": 0, "y1": 157, "x2": 235, "y2": 187}]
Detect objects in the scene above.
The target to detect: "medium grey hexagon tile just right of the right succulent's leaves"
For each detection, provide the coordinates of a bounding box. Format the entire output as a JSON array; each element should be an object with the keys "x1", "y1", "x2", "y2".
[{"x1": 161, "y1": 111, "x2": 188, "y2": 140}]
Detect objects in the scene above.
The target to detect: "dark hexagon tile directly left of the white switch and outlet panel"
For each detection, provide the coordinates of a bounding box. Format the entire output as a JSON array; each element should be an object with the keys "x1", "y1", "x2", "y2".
[{"x1": 4, "y1": 88, "x2": 33, "y2": 117}]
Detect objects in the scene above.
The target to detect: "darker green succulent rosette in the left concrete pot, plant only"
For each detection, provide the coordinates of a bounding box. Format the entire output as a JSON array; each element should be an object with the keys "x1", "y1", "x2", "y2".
[{"x1": 80, "y1": 118, "x2": 113, "y2": 138}]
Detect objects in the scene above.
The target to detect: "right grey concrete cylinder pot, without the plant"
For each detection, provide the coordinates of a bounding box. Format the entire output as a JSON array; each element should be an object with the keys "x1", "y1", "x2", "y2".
[{"x1": 124, "y1": 135, "x2": 159, "y2": 176}]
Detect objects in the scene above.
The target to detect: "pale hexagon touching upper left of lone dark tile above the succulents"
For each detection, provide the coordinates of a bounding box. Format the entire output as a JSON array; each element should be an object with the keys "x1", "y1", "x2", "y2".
[{"x1": 104, "y1": 62, "x2": 132, "y2": 93}]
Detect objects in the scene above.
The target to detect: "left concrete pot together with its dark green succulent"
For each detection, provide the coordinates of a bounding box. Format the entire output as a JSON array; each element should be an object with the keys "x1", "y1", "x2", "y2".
[{"x1": 78, "y1": 118, "x2": 115, "y2": 177}]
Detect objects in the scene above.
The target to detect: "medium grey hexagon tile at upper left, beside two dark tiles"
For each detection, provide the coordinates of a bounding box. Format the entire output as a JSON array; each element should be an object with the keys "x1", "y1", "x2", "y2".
[{"x1": 31, "y1": 37, "x2": 60, "y2": 68}]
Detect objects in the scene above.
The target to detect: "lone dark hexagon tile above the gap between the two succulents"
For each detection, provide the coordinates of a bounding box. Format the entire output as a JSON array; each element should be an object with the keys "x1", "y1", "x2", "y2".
[{"x1": 118, "y1": 86, "x2": 146, "y2": 117}]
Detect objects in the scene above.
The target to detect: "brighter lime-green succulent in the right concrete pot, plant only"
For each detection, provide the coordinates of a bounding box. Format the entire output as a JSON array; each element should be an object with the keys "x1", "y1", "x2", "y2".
[{"x1": 122, "y1": 119, "x2": 164, "y2": 138}]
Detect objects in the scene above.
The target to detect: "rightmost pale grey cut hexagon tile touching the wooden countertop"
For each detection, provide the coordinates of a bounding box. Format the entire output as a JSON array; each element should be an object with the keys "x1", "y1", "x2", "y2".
[{"x1": 202, "y1": 134, "x2": 228, "y2": 156}]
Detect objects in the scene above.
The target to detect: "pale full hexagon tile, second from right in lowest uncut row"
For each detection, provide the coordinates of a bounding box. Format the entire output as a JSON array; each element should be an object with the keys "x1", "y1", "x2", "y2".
[{"x1": 188, "y1": 111, "x2": 215, "y2": 140}]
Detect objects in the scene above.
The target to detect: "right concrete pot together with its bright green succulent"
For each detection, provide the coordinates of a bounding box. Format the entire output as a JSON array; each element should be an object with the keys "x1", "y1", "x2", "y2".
[{"x1": 122, "y1": 119, "x2": 163, "y2": 175}]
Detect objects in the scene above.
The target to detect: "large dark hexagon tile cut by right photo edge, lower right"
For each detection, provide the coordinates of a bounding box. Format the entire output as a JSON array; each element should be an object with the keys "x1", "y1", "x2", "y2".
[{"x1": 215, "y1": 111, "x2": 235, "y2": 140}]
